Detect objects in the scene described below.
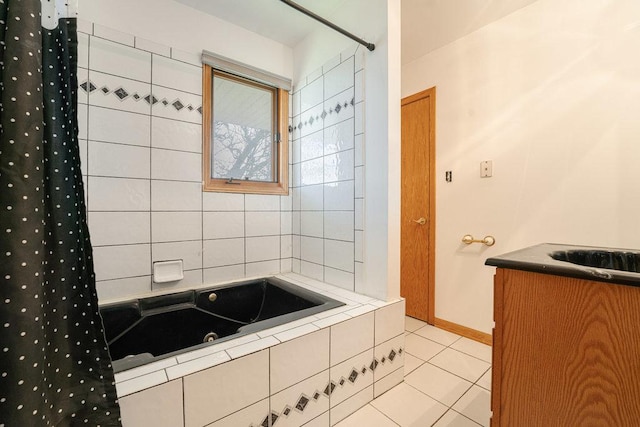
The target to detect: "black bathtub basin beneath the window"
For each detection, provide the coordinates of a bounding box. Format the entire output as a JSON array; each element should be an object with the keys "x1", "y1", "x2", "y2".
[{"x1": 100, "y1": 277, "x2": 344, "y2": 372}]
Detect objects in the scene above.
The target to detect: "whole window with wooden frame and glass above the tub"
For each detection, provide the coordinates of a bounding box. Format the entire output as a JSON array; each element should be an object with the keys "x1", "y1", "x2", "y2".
[{"x1": 202, "y1": 64, "x2": 289, "y2": 194}]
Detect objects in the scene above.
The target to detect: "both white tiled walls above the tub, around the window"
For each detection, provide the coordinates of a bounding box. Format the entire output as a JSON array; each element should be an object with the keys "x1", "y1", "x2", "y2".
[{"x1": 78, "y1": 20, "x2": 365, "y2": 306}]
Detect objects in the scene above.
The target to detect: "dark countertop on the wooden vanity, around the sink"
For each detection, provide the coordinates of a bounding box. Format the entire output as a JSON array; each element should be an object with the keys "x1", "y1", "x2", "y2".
[{"x1": 485, "y1": 243, "x2": 640, "y2": 287}]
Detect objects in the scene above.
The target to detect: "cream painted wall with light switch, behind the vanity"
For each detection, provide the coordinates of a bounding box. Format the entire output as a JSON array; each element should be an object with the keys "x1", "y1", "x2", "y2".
[{"x1": 402, "y1": 0, "x2": 640, "y2": 333}]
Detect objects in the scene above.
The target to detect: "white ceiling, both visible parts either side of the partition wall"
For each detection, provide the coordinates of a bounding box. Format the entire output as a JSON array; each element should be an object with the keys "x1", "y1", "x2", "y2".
[{"x1": 175, "y1": 0, "x2": 537, "y2": 64}]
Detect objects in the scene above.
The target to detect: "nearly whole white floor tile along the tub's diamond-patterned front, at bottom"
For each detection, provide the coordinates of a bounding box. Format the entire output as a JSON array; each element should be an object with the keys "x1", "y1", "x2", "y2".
[{"x1": 363, "y1": 383, "x2": 447, "y2": 427}]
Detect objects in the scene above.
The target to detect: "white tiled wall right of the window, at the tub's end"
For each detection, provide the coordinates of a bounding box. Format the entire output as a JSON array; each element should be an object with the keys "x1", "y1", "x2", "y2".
[{"x1": 291, "y1": 46, "x2": 365, "y2": 292}]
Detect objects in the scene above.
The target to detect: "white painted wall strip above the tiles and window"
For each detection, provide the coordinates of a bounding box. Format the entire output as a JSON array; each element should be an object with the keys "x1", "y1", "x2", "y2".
[{"x1": 79, "y1": 0, "x2": 293, "y2": 77}]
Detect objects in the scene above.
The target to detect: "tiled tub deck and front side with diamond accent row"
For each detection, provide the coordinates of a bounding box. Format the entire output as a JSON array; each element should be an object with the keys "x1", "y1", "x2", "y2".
[{"x1": 116, "y1": 273, "x2": 405, "y2": 427}]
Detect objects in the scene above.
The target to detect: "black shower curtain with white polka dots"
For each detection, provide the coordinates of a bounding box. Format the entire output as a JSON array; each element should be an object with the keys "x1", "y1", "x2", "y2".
[{"x1": 0, "y1": 0, "x2": 120, "y2": 427}]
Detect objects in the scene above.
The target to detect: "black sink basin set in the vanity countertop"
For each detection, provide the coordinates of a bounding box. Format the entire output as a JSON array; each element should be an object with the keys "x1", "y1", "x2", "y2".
[{"x1": 549, "y1": 249, "x2": 640, "y2": 273}]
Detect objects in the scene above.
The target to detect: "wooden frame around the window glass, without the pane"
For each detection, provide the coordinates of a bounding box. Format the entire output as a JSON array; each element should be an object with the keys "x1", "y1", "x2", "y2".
[{"x1": 202, "y1": 64, "x2": 289, "y2": 195}]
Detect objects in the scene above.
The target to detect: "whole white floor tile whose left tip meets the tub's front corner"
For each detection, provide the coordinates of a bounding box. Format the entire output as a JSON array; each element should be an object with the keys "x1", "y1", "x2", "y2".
[{"x1": 405, "y1": 363, "x2": 472, "y2": 406}]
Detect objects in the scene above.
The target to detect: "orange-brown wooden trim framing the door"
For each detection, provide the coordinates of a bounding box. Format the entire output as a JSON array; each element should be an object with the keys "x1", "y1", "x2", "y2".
[{"x1": 400, "y1": 86, "x2": 436, "y2": 325}]
